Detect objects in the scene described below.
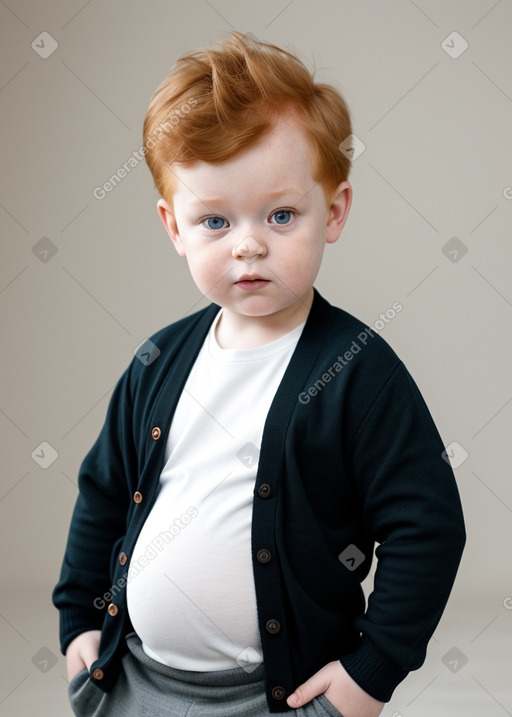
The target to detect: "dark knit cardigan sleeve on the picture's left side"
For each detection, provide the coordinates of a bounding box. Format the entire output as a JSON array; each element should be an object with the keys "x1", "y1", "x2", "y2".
[{"x1": 52, "y1": 369, "x2": 137, "y2": 653}]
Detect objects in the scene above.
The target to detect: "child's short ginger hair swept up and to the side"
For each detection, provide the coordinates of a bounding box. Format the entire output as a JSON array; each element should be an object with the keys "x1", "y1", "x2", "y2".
[{"x1": 143, "y1": 32, "x2": 352, "y2": 202}]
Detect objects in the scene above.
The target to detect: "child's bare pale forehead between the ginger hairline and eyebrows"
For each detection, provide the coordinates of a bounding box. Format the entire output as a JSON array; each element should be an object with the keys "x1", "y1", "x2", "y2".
[{"x1": 173, "y1": 113, "x2": 314, "y2": 198}]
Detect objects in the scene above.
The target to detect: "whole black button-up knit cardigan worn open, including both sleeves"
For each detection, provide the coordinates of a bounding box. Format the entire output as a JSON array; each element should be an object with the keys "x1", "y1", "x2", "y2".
[{"x1": 53, "y1": 290, "x2": 465, "y2": 712}]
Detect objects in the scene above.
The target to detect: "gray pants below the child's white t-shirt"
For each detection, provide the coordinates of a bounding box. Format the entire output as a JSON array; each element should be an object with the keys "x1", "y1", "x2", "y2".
[{"x1": 69, "y1": 632, "x2": 343, "y2": 717}]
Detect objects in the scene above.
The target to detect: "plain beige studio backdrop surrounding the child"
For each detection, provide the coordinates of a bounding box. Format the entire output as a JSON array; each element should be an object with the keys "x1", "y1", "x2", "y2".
[{"x1": 0, "y1": 0, "x2": 512, "y2": 717}]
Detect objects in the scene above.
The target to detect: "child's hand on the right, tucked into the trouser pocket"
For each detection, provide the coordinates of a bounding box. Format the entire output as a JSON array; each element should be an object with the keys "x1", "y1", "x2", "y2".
[{"x1": 286, "y1": 660, "x2": 384, "y2": 717}]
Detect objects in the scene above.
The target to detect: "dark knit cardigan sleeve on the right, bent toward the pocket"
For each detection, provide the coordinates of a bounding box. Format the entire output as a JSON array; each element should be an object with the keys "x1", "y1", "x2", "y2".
[{"x1": 341, "y1": 363, "x2": 465, "y2": 702}]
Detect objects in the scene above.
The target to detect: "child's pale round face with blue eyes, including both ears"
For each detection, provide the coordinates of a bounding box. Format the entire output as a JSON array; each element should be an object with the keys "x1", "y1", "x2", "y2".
[{"x1": 158, "y1": 116, "x2": 352, "y2": 317}]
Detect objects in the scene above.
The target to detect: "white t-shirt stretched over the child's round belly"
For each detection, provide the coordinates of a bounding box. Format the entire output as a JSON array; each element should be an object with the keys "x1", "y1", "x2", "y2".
[{"x1": 127, "y1": 310, "x2": 304, "y2": 671}]
